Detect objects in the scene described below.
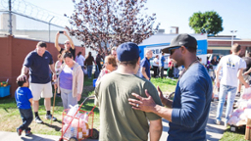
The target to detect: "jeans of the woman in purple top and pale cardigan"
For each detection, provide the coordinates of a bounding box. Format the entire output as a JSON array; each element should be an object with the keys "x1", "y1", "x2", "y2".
[{"x1": 60, "y1": 87, "x2": 78, "y2": 109}]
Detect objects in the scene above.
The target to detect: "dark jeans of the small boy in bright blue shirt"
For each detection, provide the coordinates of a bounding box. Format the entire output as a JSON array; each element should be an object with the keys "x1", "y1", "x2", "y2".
[{"x1": 18, "y1": 109, "x2": 33, "y2": 131}]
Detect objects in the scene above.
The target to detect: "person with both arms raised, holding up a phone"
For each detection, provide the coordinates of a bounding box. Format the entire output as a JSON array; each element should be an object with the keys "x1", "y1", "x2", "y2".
[{"x1": 55, "y1": 31, "x2": 75, "y2": 60}]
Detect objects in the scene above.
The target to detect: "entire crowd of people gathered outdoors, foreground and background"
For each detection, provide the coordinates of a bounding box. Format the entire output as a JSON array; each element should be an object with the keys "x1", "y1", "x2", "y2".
[{"x1": 15, "y1": 31, "x2": 251, "y2": 141}]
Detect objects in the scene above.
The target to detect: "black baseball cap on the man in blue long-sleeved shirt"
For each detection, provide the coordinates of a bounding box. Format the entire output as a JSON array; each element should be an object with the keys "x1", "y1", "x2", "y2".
[{"x1": 161, "y1": 34, "x2": 197, "y2": 53}]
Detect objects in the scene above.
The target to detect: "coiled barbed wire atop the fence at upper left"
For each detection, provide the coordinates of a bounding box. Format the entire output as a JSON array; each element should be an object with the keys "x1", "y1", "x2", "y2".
[{"x1": 0, "y1": 0, "x2": 69, "y2": 27}]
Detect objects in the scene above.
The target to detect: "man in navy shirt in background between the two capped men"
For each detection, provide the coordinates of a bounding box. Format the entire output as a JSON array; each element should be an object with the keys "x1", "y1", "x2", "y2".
[{"x1": 140, "y1": 50, "x2": 153, "y2": 81}]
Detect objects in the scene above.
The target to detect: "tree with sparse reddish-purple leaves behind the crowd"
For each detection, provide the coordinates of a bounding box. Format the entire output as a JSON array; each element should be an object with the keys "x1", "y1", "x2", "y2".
[{"x1": 65, "y1": 0, "x2": 160, "y2": 53}]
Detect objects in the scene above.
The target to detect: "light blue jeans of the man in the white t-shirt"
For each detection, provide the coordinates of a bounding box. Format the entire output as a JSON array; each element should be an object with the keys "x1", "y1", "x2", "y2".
[{"x1": 216, "y1": 85, "x2": 237, "y2": 124}]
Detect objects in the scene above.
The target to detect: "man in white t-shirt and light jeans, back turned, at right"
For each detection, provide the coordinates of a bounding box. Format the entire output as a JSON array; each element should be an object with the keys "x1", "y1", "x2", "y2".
[{"x1": 216, "y1": 44, "x2": 249, "y2": 127}]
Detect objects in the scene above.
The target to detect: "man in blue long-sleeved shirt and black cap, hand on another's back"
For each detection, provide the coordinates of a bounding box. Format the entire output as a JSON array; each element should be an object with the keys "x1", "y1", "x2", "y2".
[{"x1": 129, "y1": 34, "x2": 212, "y2": 141}]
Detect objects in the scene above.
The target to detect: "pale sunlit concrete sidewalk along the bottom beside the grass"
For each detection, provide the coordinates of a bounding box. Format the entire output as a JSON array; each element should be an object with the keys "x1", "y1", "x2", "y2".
[{"x1": 0, "y1": 102, "x2": 226, "y2": 141}]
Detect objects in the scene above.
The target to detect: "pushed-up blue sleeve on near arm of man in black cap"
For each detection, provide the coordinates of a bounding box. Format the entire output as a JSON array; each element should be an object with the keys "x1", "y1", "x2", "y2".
[{"x1": 172, "y1": 78, "x2": 207, "y2": 128}]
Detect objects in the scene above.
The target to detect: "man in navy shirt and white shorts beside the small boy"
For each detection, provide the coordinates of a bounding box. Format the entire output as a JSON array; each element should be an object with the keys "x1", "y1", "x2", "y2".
[{"x1": 17, "y1": 42, "x2": 57, "y2": 123}]
